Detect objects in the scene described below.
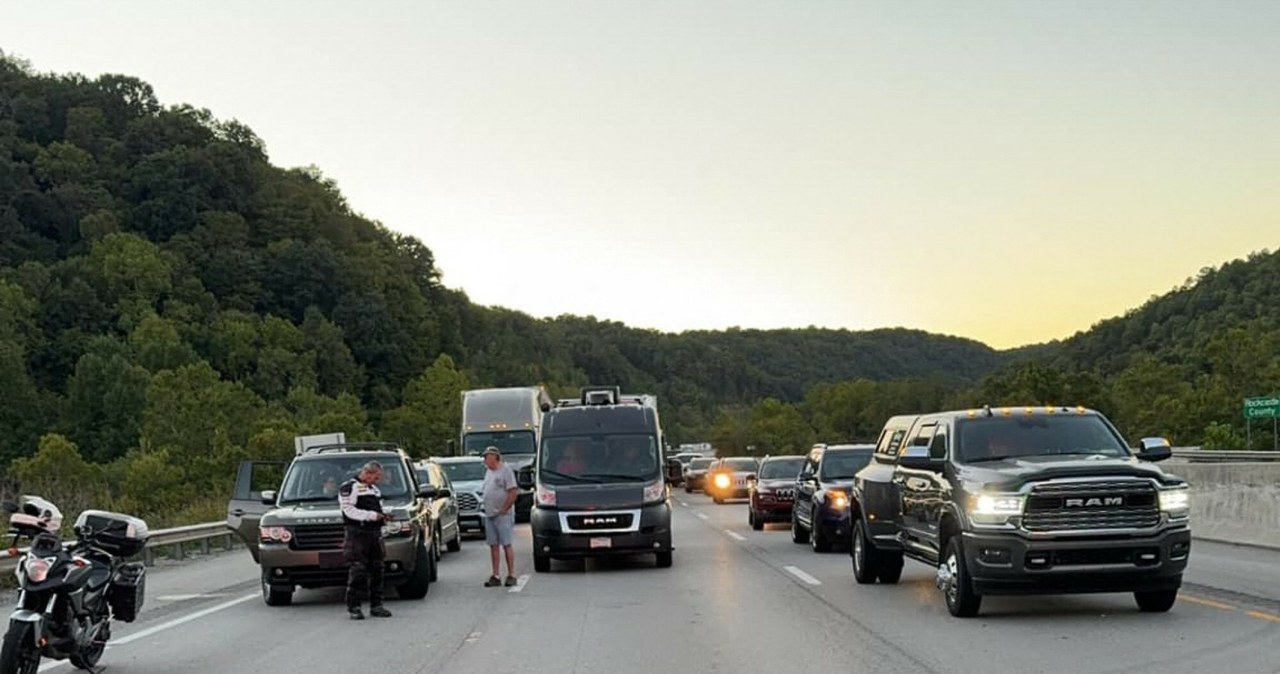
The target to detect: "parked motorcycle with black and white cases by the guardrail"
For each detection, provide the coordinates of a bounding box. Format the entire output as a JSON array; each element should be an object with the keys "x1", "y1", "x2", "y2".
[{"x1": 0, "y1": 496, "x2": 148, "y2": 674}]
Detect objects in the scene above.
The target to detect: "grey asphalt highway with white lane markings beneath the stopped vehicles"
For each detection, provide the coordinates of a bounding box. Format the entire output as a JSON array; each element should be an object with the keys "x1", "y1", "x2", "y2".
[{"x1": 22, "y1": 492, "x2": 1280, "y2": 674}]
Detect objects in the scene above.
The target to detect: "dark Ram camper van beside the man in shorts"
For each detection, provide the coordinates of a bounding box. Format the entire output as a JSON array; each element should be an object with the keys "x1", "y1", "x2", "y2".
[{"x1": 520, "y1": 388, "x2": 680, "y2": 573}]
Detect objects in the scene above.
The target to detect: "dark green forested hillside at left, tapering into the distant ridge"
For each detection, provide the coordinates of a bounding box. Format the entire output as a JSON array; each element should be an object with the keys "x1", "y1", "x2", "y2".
[{"x1": 0, "y1": 58, "x2": 1002, "y2": 519}]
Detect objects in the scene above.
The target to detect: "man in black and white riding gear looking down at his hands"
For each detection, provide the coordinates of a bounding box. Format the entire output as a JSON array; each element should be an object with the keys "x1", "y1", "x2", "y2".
[{"x1": 338, "y1": 460, "x2": 392, "y2": 620}]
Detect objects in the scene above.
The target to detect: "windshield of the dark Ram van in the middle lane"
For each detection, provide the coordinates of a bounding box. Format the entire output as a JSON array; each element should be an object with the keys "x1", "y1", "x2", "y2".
[{"x1": 538, "y1": 435, "x2": 660, "y2": 485}]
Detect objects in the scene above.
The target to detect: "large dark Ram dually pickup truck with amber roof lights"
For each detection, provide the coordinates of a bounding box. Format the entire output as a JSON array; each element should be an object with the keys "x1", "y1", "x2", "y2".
[{"x1": 850, "y1": 407, "x2": 1192, "y2": 616}]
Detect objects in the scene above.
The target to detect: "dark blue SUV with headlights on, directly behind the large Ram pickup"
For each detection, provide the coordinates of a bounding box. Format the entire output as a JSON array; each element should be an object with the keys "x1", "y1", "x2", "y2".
[{"x1": 791, "y1": 445, "x2": 876, "y2": 553}]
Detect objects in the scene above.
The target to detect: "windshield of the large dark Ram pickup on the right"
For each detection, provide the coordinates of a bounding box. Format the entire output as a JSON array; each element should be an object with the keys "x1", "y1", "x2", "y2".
[{"x1": 956, "y1": 414, "x2": 1129, "y2": 463}]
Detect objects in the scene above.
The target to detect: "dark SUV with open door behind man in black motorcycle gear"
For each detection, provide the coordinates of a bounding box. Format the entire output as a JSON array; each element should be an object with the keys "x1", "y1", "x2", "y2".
[{"x1": 227, "y1": 443, "x2": 440, "y2": 606}]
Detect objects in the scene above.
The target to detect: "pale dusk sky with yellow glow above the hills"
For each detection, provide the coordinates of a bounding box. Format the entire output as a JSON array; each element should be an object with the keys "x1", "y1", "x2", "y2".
[{"x1": 0, "y1": 0, "x2": 1280, "y2": 348}]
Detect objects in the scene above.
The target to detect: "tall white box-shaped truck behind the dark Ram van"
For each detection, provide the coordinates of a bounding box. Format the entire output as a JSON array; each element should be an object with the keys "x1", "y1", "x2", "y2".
[{"x1": 460, "y1": 386, "x2": 553, "y2": 522}]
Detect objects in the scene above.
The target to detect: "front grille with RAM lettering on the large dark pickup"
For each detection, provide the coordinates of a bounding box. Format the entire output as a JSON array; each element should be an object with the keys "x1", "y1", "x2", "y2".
[{"x1": 1023, "y1": 480, "x2": 1160, "y2": 532}]
